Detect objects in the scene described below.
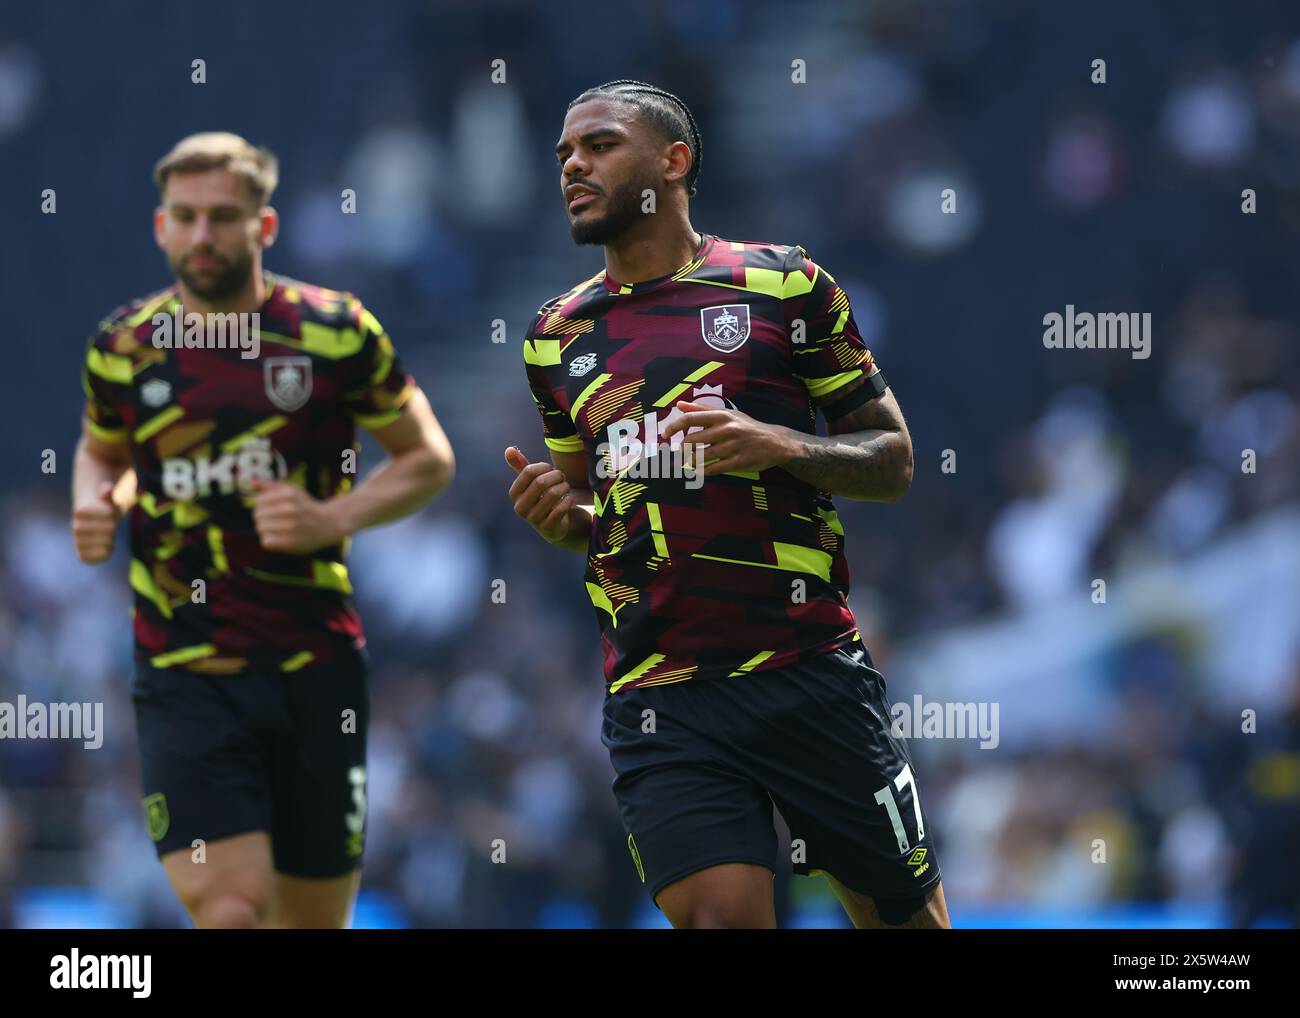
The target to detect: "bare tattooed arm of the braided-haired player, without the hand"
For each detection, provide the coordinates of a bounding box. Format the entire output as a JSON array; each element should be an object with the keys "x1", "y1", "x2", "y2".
[{"x1": 783, "y1": 377, "x2": 913, "y2": 502}]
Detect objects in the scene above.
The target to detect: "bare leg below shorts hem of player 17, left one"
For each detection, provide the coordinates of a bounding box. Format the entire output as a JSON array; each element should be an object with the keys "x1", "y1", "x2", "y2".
[{"x1": 655, "y1": 862, "x2": 776, "y2": 930}]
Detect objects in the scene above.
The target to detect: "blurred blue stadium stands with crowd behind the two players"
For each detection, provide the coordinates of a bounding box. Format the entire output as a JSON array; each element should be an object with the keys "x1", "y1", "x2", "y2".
[{"x1": 0, "y1": 0, "x2": 1300, "y2": 927}]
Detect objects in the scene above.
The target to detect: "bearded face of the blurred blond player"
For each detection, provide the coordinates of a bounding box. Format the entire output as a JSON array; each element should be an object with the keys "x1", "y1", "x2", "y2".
[{"x1": 153, "y1": 169, "x2": 274, "y2": 300}]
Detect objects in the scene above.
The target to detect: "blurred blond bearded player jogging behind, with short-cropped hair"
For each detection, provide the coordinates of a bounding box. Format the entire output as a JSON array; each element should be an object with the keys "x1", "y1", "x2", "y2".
[{"x1": 73, "y1": 133, "x2": 454, "y2": 927}]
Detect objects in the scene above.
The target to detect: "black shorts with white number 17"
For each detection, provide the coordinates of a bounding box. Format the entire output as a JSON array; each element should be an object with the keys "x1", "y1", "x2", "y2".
[{"x1": 601, "y1": 642, "x2": 940, "y2": 914}]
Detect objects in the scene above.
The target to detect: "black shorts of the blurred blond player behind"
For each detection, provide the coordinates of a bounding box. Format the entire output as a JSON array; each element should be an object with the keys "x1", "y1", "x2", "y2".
[{"x1": 131, "y1": 651, "x2": 371, "y2": 878}]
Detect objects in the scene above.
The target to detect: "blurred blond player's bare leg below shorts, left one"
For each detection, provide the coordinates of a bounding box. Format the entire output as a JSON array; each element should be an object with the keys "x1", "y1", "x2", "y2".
[{"x1": 163, "y1": 831, "x2": 273, "y2": 928}]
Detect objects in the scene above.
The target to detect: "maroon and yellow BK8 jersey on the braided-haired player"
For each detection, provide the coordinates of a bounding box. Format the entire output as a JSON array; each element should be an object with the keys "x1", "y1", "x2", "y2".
[{"x1": 524, "y1": 235, "x2": 875, "y2": 692}]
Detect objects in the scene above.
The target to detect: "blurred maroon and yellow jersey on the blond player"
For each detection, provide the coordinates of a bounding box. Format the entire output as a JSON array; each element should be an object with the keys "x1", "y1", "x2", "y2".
[{"x1": 82, "y1": 273, "x2": 415, "y2": 672}]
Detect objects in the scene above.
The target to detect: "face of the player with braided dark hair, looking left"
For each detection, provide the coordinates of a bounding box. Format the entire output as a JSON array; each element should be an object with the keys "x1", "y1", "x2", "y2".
[{"x1": 555, "y1": 99, "x2": 662, "y2": 244}]
